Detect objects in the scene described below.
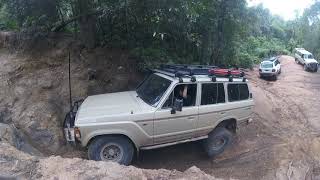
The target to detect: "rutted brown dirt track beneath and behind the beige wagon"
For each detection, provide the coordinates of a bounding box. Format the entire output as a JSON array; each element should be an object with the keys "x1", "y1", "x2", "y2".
[{"x1": 135, "y1": 56, "x2": 320, "y2": 179}]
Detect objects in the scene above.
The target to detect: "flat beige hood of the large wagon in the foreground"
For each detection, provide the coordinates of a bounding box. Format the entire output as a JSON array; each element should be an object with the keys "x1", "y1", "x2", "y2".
[{"x1": 76, "y1": 91, "x2": 142, "y2": 123}]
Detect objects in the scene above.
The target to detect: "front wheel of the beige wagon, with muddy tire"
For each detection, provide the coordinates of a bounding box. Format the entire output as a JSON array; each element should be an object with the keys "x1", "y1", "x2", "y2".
[{"x1": 88, "y1": 136, "x2": 134, "y2": 165}]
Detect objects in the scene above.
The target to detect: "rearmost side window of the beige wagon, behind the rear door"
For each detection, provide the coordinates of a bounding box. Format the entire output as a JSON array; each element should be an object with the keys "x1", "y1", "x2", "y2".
[{"x1": 228, "y1": 84, "x2": 249, "y2": 102}]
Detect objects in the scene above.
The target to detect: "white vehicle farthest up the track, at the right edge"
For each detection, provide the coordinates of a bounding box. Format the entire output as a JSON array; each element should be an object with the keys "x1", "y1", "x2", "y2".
[{"x1": 294, "y1": 48, "x2": 319, "y2": 72}]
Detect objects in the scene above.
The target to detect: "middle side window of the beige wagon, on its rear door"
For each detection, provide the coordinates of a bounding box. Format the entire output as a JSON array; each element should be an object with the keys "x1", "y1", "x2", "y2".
[{"x1": 201, "y1": 83, "x2": 225, "y2": 105}]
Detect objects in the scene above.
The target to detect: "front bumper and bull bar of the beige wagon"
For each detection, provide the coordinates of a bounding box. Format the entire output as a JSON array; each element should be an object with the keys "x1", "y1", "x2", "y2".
[{"x1": 63, "y1": 100, "x2": 83, "y2": 143}]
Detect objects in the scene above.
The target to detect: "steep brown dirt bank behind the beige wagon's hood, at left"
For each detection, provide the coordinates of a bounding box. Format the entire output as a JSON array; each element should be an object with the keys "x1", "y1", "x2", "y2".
[{"x1": 0, "y1": 33, "x2": 141, "y2": 154}]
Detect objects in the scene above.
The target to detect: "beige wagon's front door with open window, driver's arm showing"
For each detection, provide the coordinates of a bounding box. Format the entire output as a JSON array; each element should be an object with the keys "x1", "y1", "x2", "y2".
[{"x1": 154, "y1": 84, "x2": 198, "y2": 144}]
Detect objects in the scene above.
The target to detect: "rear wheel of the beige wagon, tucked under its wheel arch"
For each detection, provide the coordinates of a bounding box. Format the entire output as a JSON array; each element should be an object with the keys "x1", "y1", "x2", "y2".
[{"x1": 203, "y1": 127, "x2": 233, "y2": 157}]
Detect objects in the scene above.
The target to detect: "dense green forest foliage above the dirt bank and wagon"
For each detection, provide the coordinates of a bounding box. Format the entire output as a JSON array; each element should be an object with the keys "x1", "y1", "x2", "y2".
[{"x1": 0, "y1": 0, "x2": 320, "y2": 68}]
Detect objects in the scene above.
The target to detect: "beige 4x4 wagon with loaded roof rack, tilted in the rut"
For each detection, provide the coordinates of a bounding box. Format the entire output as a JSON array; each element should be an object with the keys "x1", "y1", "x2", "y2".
[{"x1": 65, "y1": 66, "x2": 254, "y2": 165}]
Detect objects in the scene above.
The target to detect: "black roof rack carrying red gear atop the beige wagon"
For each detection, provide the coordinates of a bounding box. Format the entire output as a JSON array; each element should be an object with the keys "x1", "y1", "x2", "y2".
[{"x1": 154, "y1": 64, "x2": 246, "y2": 82}]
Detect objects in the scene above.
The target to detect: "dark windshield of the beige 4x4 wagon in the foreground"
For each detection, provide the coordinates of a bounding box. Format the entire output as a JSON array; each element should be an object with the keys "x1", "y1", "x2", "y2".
[{"x1": 137, "y1": 74, "x2": 171, "y2": 106}]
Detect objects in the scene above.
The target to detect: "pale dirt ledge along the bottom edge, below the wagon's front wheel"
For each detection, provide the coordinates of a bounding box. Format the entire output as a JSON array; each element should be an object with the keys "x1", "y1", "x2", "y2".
[{"x1": 0, "y1": 142, "x2": 221, "y2": 180}]
